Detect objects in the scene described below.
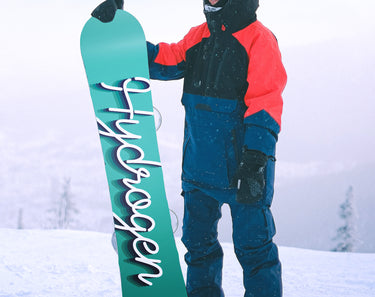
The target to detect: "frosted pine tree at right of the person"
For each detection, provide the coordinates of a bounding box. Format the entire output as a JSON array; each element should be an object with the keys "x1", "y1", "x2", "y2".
[{"x1": 332, "y1": 186, "x2": 357, "y2": 252}]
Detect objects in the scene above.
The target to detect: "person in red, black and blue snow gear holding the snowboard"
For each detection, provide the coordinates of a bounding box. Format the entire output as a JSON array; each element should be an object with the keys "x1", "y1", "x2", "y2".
[{"x1": 93, "y1": 0, "x2": 286, "y2": 297}]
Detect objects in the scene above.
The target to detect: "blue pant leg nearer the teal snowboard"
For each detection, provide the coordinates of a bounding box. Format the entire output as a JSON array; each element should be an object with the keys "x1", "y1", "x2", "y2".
[{"x1": 182, "y1": 190, "x2": 224, "y2": 297}]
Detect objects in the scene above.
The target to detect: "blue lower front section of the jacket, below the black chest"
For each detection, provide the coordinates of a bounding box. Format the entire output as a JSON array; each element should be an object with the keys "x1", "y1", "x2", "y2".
[{"x1": 183, "y1": 95, "x2": 242, "y2": 189}]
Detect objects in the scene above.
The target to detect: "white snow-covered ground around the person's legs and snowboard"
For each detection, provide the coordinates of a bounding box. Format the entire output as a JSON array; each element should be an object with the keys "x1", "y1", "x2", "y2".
[{"x1": 0, "y1": 229, "x2": 375, "y2": 297}]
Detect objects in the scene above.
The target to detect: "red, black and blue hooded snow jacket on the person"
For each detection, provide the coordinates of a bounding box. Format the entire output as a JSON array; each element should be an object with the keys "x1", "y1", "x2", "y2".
[{"x1": 148, "y1": 0, "x2": 286, "y2": 188}]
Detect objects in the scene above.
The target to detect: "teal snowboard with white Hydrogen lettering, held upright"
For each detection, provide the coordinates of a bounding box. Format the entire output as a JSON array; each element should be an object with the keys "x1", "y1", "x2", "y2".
[{"x1": 81, "y1": 10, "x2": 186, "y2": 297}]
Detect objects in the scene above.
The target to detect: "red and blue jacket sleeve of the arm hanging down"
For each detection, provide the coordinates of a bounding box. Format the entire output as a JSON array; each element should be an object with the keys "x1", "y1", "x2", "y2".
[{"x1": 244, "y1": 31, "x2": 287, "y2": 156}]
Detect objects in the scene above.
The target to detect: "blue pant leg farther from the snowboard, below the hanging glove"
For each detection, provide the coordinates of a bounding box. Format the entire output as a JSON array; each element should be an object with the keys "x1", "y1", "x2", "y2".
[{"x1": 230, "y1": 160, "x2": 282, "y2": 297}]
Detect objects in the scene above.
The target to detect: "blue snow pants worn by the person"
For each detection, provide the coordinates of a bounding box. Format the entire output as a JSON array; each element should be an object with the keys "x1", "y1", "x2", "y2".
[{"x1": 182, "y1": 161, "x2": 282, "y2": 297}]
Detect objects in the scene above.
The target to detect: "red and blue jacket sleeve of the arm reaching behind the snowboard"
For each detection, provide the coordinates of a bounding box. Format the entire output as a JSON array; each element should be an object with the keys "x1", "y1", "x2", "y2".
[{"x1": 147, "y1": 24, "x2": 209, "y2": 80}]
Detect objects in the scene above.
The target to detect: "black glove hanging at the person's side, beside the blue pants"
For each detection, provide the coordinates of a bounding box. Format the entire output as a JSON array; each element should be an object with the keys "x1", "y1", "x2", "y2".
[{"x1": 231, "y1": 148, "x2": 268, "y2": 204}]
